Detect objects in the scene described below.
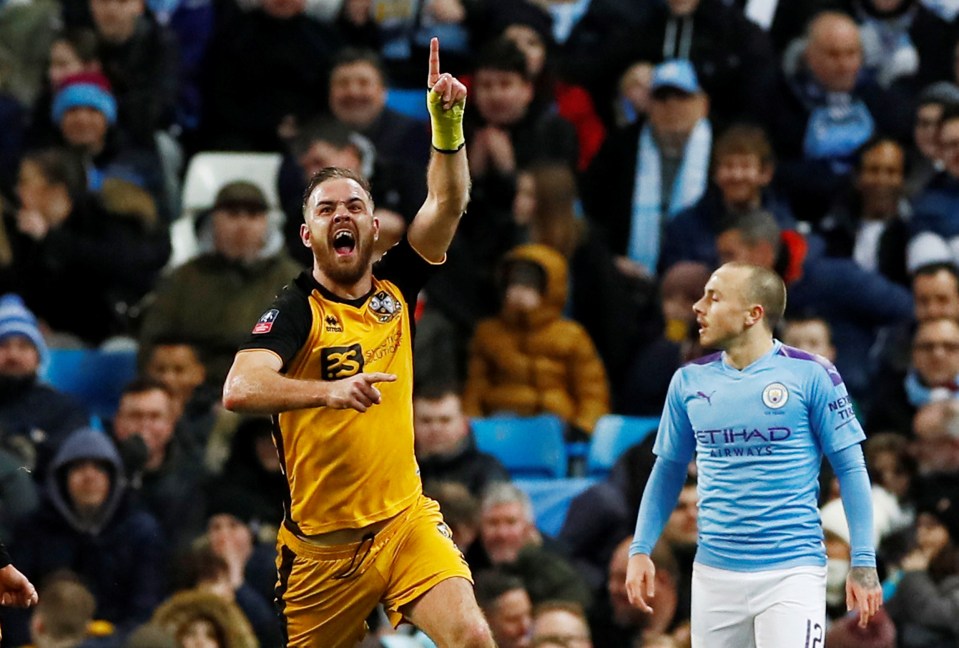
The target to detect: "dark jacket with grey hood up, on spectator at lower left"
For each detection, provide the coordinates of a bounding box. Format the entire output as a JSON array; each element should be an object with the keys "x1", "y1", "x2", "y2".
[{"x1": 3, "y1": 428, "x2": 164, "y2": 646}]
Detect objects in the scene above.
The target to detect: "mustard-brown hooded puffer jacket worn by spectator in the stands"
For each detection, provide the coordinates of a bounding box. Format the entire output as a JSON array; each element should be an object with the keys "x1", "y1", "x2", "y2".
[{"x1": 463, "y1": 244, "x2": 609, "y2": 433}]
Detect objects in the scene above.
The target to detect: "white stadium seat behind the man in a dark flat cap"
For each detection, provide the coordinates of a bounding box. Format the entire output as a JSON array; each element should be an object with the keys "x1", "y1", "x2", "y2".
[{"x1": 167, "y1": 151, "x2": 285, "y2": 268}]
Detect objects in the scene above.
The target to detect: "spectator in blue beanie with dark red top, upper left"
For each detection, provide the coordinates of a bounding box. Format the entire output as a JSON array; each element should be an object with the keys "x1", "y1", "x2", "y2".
[{"x1": 50, "y1": 71, "x2": 170, "y2": 218}]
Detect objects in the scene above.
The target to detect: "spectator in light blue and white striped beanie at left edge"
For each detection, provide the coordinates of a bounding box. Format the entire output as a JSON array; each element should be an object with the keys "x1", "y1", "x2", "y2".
[{"x1": 0, "y1": 294, "x2": 90, "y2": 480}]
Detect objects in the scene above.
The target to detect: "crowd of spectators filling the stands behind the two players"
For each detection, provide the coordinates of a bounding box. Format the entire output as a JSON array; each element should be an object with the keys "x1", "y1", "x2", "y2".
[{"x1": 7, "y1": 0, "x2": 959, "y2": 648}]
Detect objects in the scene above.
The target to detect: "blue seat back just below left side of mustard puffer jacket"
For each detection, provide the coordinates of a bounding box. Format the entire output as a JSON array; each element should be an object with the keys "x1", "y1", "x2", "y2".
[{"x1": 472, "y1": 414, "x2": 568, "y2": 478}]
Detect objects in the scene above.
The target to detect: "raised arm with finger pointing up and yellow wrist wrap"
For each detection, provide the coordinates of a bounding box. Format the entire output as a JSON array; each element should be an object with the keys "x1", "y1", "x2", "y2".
[{"x1": 407, "y1": 38, "x2": 470, "y2": 262}]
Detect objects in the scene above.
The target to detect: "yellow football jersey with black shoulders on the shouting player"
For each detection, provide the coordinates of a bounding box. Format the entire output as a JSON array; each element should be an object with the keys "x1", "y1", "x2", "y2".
[{"x1": 240, "y1": 239, "x2": 435, "y2": 535}]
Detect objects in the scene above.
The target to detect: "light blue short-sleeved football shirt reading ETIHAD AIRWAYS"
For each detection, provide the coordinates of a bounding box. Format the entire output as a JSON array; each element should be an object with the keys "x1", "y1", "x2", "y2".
[{"x1": 654, "y1": 340, "x2": 865, "y2": 571}]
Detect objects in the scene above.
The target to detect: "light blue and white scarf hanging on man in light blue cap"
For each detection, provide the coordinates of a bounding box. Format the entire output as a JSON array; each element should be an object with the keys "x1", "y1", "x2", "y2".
[{"x1": 627, "y1": 119, "x2": 713, "y2": 274}]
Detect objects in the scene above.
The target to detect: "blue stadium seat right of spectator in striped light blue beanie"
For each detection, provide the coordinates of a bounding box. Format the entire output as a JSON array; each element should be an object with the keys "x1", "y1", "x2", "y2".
[{"x1": 41, "y1": 349, "x2": 137, "y2": 421}]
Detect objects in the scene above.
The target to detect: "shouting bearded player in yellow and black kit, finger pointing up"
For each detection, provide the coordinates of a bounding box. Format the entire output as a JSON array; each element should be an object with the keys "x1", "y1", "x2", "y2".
[{"x1": 223, "y1": 38, "x2": 495, "y2": 648}]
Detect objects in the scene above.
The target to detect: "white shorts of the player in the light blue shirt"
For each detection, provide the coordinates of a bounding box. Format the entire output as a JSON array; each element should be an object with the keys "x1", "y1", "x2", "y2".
[{"x1": 691, "y1": 563, "x2": 826, "y2": 648}]
